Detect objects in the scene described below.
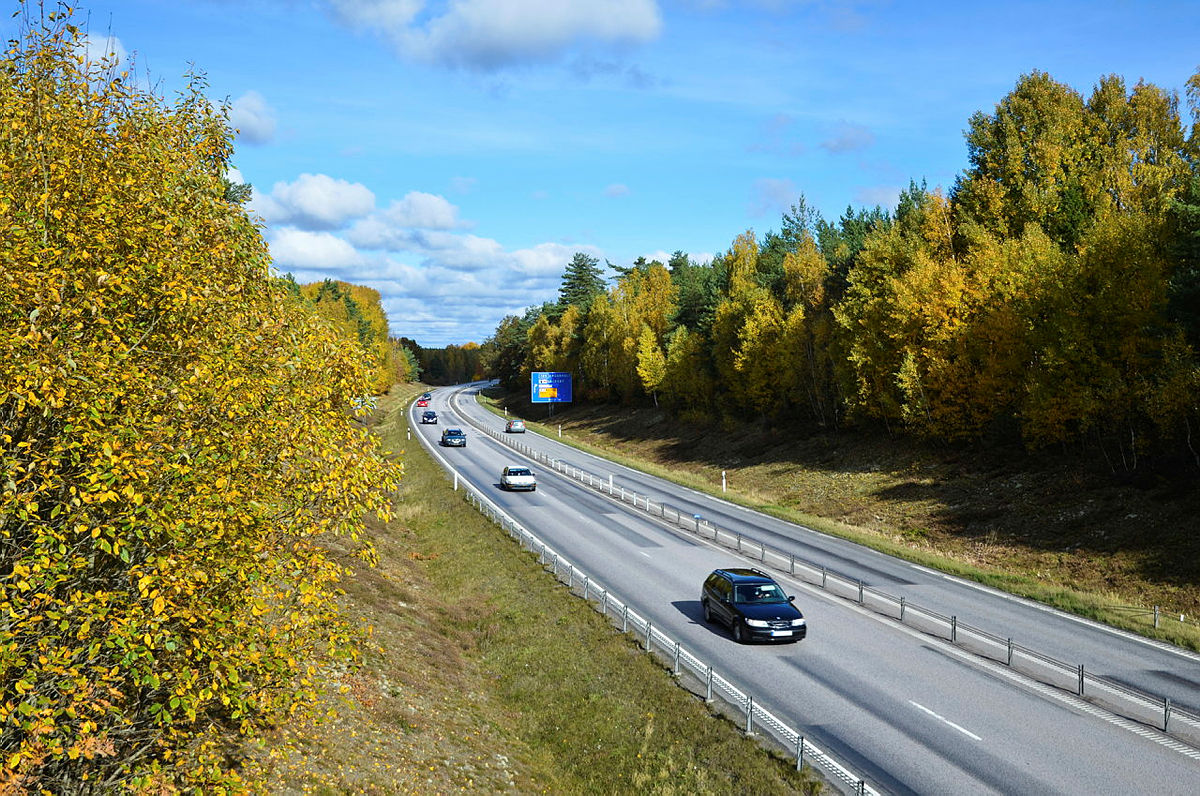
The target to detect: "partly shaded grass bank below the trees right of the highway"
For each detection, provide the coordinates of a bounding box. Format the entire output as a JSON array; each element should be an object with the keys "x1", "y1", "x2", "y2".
[{"x1": 481, "y1": 391, "x2": 1200, "y2": 650}]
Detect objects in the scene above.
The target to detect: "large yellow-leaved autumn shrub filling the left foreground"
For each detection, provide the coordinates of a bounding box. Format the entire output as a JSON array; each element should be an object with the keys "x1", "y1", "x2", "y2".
[{"x1": 0, "y1": 6, "x2": 398, "y2": 792}]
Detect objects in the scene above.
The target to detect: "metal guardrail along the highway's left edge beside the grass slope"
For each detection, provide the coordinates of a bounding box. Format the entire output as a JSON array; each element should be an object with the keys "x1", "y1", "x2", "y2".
[{"x1": 416, "y1": 405, "x2": 880, "y2": 796}]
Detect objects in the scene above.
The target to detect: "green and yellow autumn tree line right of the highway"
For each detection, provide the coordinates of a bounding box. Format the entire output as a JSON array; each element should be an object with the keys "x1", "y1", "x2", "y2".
[{"x1": 485, "y1": 72, "x2": 1200, "y2": 468}]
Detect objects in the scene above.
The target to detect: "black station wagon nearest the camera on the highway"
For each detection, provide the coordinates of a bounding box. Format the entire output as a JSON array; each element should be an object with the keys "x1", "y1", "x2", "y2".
[{"x1": 700, "y1": 568, "x2": 809, "y2": 644}]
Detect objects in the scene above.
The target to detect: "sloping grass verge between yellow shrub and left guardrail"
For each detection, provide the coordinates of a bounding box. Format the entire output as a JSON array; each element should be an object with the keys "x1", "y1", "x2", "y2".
[{"x1": 262, "y1": 385, "x2": 820, "y2": 794}]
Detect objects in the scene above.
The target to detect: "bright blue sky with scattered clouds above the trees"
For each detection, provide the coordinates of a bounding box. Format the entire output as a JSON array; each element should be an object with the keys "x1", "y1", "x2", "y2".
[{"x1": 11, "y1": 0, "x2": 1200, "y2": 347}]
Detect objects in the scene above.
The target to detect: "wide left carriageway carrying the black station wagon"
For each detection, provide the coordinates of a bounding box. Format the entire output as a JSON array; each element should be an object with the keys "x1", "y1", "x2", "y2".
[{"x1": 418, "y1": 391, "x2": 1200, "y2": 794}]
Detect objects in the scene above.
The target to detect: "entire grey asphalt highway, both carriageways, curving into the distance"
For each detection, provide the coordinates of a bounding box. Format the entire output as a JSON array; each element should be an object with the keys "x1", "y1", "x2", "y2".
[{"x1": 409, "y1": 389, "x2": 1200, "y2": 794}]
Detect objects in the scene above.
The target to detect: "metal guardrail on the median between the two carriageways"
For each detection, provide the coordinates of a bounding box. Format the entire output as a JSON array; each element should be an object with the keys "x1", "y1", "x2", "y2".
[{"x1": 456, "y1": 398, "x2": 1200, "y2": 746}]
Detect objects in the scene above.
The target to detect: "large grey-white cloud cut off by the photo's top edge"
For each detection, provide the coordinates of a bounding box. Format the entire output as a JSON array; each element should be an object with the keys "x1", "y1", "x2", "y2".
[{"x1": 329, "y1": 0, "x2": 662, "y2": 71}]
